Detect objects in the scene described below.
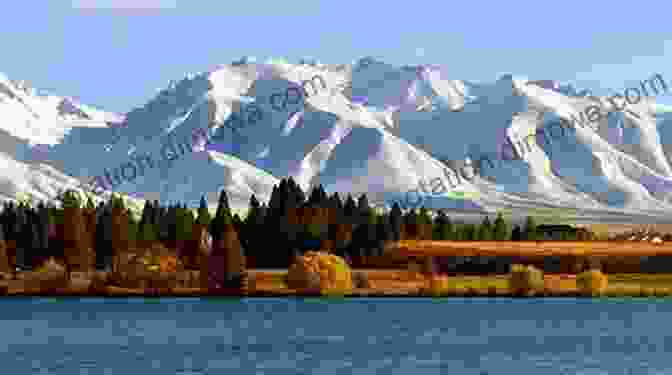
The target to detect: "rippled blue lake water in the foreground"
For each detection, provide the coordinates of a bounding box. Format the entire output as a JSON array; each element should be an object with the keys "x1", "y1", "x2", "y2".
[{"x1": 0, "y1": 298, "x2": 672, "y2": 375}]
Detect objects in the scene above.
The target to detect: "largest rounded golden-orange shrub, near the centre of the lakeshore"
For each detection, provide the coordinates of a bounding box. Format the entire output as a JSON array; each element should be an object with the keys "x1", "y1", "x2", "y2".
[{"x1": 287, "y1": 251, "x2": 353, "y2": 294}]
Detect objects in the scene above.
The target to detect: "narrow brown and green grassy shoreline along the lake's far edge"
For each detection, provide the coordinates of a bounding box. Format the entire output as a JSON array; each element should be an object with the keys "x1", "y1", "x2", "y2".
[{"x1": 0, "y1": 269, "x2": 672, "y2": 299}]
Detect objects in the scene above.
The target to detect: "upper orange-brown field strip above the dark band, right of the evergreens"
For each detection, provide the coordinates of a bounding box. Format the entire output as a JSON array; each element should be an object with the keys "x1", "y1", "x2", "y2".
[{"x1": 386, "y1": 241, "x2": 672, "y2": 257}]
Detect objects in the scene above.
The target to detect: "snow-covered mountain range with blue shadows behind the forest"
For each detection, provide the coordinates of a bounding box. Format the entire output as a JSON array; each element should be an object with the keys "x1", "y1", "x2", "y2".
[{"x1": 0, "y1": 57, "x2": 672, "y2": 222}]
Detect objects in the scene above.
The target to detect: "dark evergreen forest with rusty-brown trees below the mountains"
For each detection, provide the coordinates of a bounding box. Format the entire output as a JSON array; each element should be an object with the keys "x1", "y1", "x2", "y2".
[{"x1": 0, "y1": 178, "x2": 592, "y2": 279}]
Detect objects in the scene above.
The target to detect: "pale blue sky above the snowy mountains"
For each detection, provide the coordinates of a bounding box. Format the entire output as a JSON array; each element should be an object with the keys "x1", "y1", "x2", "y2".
[{"x1": 0, "y1": 0, "x2": 672, "y2": 112}]
